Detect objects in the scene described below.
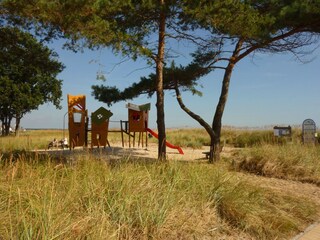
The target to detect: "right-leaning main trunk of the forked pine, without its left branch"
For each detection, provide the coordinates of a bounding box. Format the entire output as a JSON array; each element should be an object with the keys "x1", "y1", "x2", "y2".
[{"x1": 210, "y1": 39, "x2": 243, "y2": 162}]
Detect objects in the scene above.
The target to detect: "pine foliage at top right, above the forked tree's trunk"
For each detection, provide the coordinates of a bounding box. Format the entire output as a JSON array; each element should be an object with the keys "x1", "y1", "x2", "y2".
[{"x1": 184, "y1": 0, "x2": 320, "y2": 40}]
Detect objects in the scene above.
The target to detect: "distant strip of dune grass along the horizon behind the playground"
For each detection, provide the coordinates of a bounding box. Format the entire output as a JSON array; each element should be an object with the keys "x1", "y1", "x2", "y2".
[{"x1": 0, "y1": 125, "x2": 301, "y2": 150}]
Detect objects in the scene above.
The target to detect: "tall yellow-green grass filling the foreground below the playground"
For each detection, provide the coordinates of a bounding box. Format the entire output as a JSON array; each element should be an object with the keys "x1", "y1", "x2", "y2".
[{"x1": 0, "y1": 155, "x2": 317, "y2": 239}]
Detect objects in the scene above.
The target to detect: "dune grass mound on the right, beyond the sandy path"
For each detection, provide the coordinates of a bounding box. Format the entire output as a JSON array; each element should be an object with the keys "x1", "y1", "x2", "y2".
[{"x1": 233, "y1": 144, "x2": 320, "y2": 186}]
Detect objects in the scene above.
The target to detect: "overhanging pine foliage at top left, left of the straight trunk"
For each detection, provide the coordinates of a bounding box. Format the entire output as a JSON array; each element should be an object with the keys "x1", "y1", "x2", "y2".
[{"x1": 0, "y1": 0, "x2": 180, "y2": 55}]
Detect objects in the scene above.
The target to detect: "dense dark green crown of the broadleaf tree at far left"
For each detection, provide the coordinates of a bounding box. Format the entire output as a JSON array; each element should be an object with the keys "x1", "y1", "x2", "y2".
[{"x1": 0, "y1": 27, "x2": 64, "y2": 134}]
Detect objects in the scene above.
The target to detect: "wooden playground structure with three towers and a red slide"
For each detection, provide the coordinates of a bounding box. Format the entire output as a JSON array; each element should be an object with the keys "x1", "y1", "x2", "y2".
[{"x1": 68, "y1": 94, "x2": 183, "y2": 154}]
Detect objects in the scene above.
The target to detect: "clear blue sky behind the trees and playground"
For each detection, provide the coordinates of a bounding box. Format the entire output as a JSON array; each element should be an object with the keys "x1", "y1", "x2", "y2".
[{"x1": 21, "y1": 39, "x2": 320, "y2": 128}]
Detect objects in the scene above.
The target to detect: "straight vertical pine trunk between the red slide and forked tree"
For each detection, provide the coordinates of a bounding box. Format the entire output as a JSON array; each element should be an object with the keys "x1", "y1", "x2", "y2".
[{"x1": 156, "y1": 0, "x2": 166, "y2": 160}]
